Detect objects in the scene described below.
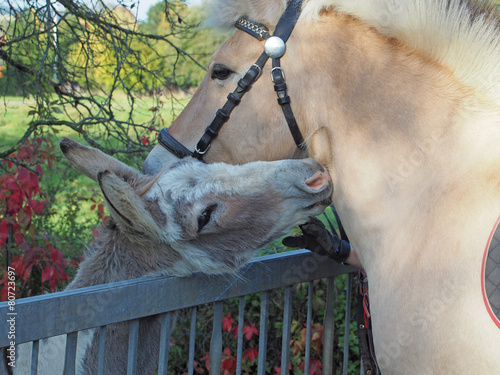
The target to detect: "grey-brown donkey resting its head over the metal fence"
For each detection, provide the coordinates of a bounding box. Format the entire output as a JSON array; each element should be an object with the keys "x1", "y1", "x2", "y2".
[{"x1": 15, "y1": 138, "x2": 332, "y2": 375}]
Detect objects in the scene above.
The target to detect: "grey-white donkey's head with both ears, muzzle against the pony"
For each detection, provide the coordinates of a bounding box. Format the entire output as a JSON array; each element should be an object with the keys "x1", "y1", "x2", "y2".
[{"x1": 61, "y1": 138, "x2": 332, "y2": 274}]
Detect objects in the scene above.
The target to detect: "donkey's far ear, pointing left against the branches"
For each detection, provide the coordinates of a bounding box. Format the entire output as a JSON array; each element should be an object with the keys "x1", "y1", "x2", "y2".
[{"x1": 59, "y1": 138, "x2": 139, "y2": 181}]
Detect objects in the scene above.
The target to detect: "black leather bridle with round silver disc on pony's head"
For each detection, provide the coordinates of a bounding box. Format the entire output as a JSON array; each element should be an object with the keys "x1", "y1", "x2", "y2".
[{"x1": 158, "y1": 0, "x2": 306, "y2": 160}]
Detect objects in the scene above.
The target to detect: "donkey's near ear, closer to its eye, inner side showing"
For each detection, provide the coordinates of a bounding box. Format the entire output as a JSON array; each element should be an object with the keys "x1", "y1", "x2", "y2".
[{"x1": 97, "y1": 171, "x2": 162, "y2": 239}]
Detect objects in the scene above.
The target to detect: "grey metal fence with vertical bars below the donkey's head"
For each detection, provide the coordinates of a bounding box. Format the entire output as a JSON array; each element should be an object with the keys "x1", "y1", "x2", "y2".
[{"x1": 0, "y1": 250, "x2": 355, "y2": 375}]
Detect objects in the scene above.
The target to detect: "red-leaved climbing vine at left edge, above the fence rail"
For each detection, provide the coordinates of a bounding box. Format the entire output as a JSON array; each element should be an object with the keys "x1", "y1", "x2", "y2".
[{"x1": 0, "y1": 133, "x2": 74, "y2": 301}]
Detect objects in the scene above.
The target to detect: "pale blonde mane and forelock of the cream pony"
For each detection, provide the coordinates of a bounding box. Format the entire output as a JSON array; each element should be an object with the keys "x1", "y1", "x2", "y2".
[{"x1": 213, "y1": 0, "x2": 500, "y2": 102}]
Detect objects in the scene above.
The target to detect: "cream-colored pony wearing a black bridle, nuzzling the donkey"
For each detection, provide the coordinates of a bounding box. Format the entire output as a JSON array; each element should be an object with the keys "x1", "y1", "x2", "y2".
[{"x1": 144, "y1": 0, "x2": 500, "y2": 375}]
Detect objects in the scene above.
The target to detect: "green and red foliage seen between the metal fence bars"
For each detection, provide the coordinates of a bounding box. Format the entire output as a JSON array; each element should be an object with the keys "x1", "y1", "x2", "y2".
[{"x1": 168, "y1": 275, "x2": 360, "y2": 375}]
